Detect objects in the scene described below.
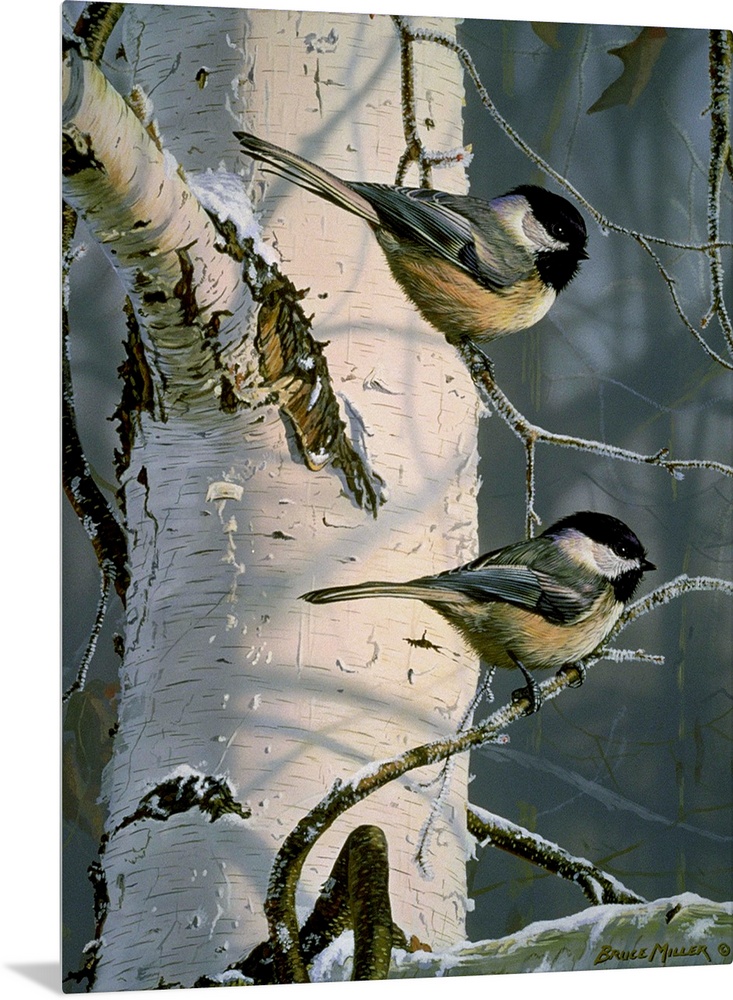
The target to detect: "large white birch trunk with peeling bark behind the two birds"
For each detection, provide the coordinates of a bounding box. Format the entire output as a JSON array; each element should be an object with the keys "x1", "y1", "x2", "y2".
[{"x1": 64, "y1": 6, "x2": 478, "y2": 990}]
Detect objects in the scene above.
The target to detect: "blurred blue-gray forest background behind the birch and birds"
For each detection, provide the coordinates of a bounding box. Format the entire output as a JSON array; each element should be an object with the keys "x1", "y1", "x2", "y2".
[{"x1": 63, "y1": 4, "x2": 733, "y2": 971}]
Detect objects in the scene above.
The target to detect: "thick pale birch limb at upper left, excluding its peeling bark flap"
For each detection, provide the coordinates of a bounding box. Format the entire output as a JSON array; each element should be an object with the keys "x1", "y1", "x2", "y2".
[{"x1": 63, "y1": 49, "x2": 246, "y2": 398}]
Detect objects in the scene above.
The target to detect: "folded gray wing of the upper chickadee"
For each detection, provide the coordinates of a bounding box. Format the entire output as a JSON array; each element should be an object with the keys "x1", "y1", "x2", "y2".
[{"x1": 349, "y1": 181, "x2": 534, "y2": 289}]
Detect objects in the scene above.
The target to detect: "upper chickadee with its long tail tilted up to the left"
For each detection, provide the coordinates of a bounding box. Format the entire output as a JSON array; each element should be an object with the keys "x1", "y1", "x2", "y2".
[{"x1": 234, "y1": 132, "x2": 588, "y2": 343}]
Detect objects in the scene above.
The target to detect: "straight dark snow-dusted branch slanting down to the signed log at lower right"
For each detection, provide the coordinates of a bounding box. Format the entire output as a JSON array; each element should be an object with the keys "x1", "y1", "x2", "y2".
[{"x1": 467, "y1": 805, "x2": 646, "y2": 906}]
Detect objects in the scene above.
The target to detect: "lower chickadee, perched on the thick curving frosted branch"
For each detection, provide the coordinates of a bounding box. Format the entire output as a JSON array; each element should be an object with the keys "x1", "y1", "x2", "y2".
[{"x1": 301, "y1": 511, "x2": 656, "y2": 712}]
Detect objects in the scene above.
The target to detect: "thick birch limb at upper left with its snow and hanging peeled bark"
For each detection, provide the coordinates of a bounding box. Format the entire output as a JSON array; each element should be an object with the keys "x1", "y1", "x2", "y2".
[{"x1": 64, "y1": 49, "x2": 384, "y2": 516}]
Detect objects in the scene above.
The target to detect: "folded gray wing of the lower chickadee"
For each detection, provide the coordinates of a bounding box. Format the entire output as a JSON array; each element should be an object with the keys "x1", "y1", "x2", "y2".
[{"x1": 415, "y1": 563, "x2": 598, "y2": 625}]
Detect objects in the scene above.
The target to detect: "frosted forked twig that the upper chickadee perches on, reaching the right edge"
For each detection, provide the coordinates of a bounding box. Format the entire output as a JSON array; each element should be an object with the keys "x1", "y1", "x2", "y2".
[{"x1": 459, "y1": 340, "x2": 733, "y2": 537}]
